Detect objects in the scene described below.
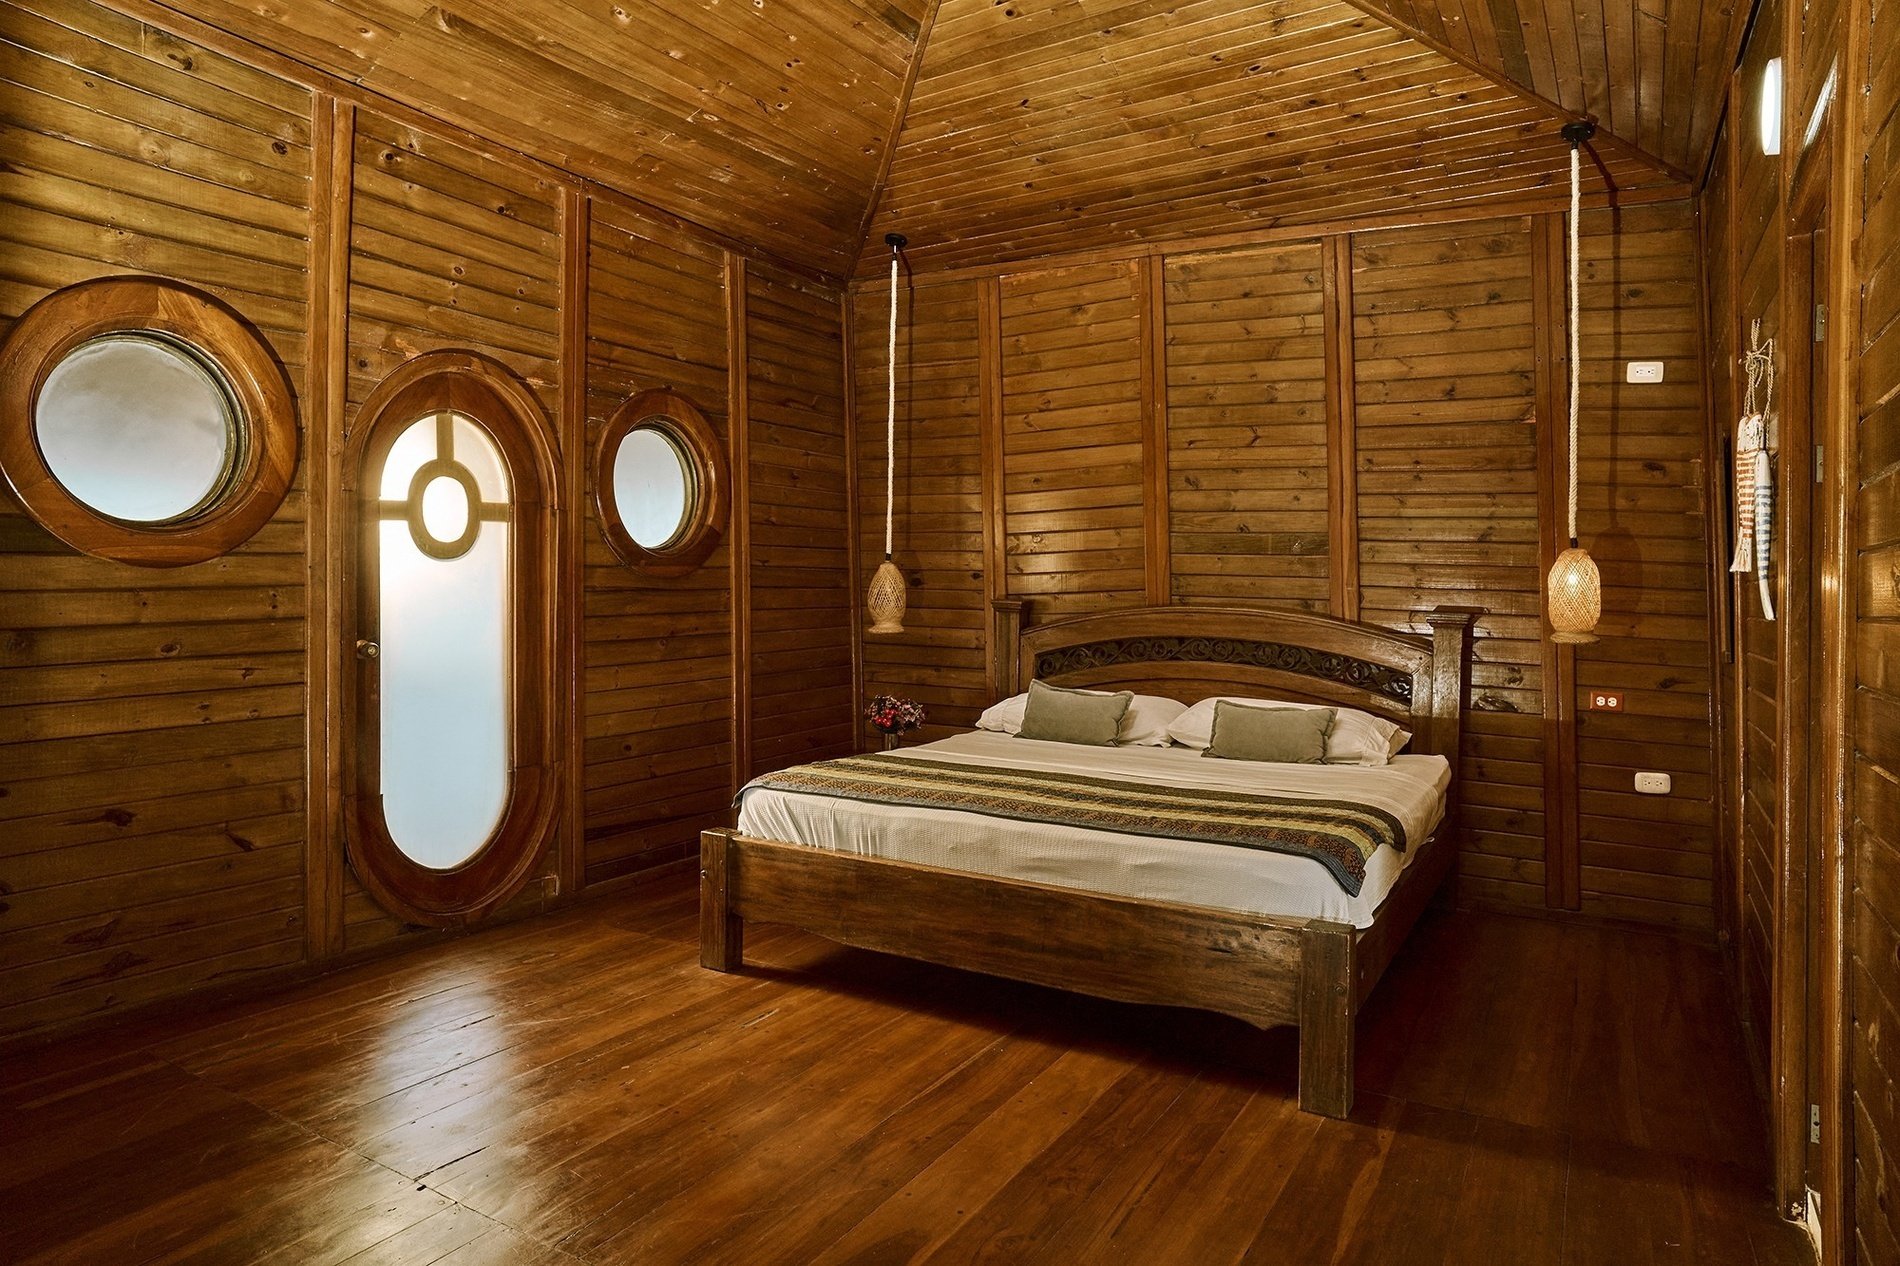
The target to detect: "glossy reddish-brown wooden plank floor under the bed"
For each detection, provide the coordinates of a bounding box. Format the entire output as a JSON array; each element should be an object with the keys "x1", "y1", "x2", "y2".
[{"x1": 0, "y1": 884, "x2": 1807, "y2": 1266}]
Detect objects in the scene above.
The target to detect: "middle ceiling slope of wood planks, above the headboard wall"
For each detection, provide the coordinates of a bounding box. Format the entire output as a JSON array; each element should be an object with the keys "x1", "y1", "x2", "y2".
[{"x1": 863, "y1": 0, "x2": 1685, "y2": 272}]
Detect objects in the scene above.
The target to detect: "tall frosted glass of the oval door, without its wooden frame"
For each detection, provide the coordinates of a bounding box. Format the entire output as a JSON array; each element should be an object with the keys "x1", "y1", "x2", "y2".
[{"x1": 378, "y1": 418, "x2": 511, "y2": 869}]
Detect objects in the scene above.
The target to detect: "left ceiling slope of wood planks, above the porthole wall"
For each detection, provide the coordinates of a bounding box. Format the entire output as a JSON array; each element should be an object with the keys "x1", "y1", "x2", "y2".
[{"x1": 152, "y1": 0, "x2": 929, "y2": 274}]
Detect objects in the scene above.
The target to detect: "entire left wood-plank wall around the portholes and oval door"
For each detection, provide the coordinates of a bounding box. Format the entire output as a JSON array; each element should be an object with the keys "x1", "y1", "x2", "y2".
[{"x1": 0, "y1": 0, "x2": 855, "y2": 1042}]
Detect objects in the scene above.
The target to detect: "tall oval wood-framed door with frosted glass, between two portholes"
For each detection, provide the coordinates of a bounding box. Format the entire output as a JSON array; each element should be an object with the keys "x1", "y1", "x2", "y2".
[{"x1": 346, "y1": 352, "x2": 557, "y2": 926}]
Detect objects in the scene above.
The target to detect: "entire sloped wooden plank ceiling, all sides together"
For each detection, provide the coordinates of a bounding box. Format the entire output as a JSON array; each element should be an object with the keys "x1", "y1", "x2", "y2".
[{"x1": 160, "y1": 0, "x2": 1746, "y2": 276}]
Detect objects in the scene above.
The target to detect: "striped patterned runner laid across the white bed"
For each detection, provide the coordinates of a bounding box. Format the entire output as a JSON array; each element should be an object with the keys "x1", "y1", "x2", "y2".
[{"x1": 739, "y1": 755, "x2": 1406, "y2": 897}]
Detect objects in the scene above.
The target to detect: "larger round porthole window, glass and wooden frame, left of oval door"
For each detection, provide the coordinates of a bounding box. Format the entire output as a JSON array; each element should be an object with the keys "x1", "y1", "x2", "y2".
[{"x1": 0, "y1": 278, "x2": 296, "y2": 566}]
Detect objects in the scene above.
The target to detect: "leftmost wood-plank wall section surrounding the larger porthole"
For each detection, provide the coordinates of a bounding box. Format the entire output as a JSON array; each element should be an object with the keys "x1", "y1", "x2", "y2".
[{"x1": 0, "y1": 2, "x2": 314, "y2": 1036}]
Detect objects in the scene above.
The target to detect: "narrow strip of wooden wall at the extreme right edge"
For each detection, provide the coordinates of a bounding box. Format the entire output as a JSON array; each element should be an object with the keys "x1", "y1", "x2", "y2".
[{"x1": 1843, "y1": 4, "x2": 1900, "y2": 1264}]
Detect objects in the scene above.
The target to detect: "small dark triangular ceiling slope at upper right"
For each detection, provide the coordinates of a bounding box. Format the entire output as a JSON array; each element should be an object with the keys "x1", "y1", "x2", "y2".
[{"x1": 1355, "y1": 0, "x2": 1752, "y2": 177}]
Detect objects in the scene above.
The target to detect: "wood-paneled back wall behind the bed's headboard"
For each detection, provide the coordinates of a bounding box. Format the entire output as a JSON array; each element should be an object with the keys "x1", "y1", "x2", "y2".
[{"x1": 853, "y1": 203, "x2": 1714, "y2": 931}]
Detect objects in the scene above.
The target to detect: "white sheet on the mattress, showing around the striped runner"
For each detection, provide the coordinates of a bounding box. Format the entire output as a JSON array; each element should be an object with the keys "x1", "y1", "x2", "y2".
[{"x1": 739, "y1": 730, "x2": 1452, "y2": 928}]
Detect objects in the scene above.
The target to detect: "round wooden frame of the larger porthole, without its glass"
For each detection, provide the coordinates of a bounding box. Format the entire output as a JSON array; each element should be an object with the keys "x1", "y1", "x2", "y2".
[{"x1": 0, "y1": 278, "x2": 298, "y2": 566}]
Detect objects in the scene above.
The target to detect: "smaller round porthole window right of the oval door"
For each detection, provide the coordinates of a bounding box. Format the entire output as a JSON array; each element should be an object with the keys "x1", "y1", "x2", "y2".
[{"x1": 593, "y1": 392, "x2": 726, "y2": 576}]
